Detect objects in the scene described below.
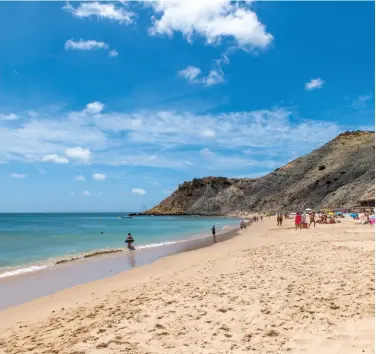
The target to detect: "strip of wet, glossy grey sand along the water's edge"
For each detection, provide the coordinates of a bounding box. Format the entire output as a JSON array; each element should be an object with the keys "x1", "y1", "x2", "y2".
[{"x1": 0, "y1": 225, "x2": 245, "y2": 311}]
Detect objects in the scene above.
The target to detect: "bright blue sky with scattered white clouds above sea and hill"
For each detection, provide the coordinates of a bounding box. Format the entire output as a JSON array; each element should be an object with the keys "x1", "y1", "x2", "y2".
[{"x1": 0, "y1": 0, "x2": 375, "y2": 212}]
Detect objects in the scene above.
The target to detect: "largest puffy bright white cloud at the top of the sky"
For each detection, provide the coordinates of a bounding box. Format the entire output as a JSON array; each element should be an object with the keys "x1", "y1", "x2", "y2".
[{"x1": 149, "y1": 0, "x2": 273, "y2": 50}]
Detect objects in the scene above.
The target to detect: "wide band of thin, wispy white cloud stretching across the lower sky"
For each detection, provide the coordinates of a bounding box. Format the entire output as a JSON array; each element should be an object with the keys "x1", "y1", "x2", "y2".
[{"x1": 0, "y1": 101, "x2": 346, "y2": 175}]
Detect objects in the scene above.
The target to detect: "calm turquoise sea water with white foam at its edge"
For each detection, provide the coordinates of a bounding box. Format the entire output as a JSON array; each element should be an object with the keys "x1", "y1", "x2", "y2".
[{"x1": 0, "y1": 213, "x2": 238, "y2": 278}]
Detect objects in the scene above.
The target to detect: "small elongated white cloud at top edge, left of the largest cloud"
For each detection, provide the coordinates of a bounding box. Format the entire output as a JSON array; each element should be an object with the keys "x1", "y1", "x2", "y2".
[{"x1": 63, "y1": 2, "x2": 135, "y2": 25}]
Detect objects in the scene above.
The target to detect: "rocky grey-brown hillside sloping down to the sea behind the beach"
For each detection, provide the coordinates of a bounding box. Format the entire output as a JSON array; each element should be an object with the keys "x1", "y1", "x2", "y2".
[{"x1": 145, "y1": 131, "x2": 375, "y2": 215}]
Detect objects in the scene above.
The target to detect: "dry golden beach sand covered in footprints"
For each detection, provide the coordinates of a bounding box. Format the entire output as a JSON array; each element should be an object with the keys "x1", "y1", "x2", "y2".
[{"x1": 0, "y1": 218, "x2": 374, "y2": 354}]
